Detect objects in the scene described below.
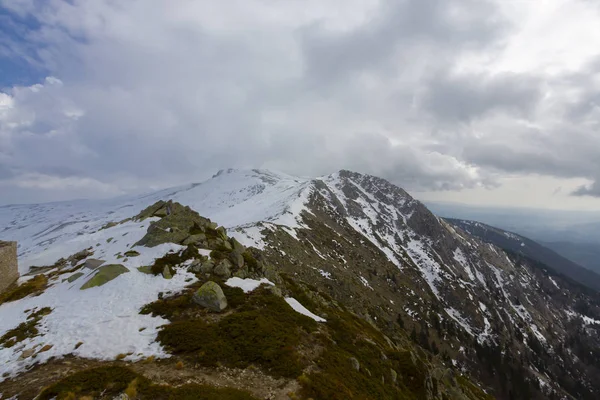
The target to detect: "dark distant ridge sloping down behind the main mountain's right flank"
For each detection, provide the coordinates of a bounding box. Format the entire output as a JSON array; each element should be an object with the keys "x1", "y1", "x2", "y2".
[{"x1": 446, "y1": 218, "x2": 600, "y2": 291}]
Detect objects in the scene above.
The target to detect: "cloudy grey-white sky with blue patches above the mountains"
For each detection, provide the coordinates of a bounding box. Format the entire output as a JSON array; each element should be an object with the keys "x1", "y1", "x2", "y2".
[{"x1": 0, "y1": 0, "x2": 600, "y2": 210}]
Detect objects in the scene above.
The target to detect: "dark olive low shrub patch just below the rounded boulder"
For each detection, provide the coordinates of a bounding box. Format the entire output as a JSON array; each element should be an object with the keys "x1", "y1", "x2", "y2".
[{"x1": 158, "y1": 289, "x2": 316, "y2": 378}]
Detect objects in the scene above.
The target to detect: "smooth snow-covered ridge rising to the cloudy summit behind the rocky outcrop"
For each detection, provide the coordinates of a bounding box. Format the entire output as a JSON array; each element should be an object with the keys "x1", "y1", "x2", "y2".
[{"x1": 0, "y1": 170, "x2": 311, "y2": 273}]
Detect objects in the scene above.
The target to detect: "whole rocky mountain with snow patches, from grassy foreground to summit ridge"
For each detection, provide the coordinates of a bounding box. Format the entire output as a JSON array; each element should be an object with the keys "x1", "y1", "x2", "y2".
[{"x1": 0, "y1": 170, "x2": 600, "y2": 399}]
